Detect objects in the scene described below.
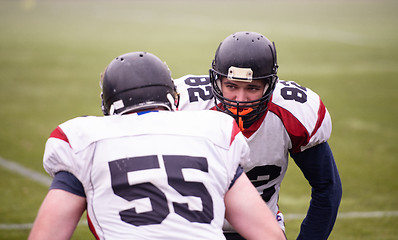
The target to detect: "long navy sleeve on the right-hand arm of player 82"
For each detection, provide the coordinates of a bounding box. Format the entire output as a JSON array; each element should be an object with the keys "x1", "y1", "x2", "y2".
[{"x1": 291, "y1": 142, "x2": 342, "y2": 240}]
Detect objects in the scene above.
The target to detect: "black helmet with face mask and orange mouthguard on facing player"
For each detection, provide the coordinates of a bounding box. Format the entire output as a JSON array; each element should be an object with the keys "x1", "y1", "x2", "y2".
[{"x1": 209, "y1": 32, "x2": 278, "y2": 128}]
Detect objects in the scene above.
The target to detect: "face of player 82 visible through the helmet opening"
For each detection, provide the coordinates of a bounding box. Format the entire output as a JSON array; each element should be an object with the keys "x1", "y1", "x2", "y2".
[{"x1": 221, "y1": 77, "x2": 265, "y2": 105}]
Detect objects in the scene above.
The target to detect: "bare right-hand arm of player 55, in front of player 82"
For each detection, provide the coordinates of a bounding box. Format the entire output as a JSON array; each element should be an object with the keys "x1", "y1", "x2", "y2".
[{"x1": 224, "y1": 173, "x2": 285, "y2": 240}]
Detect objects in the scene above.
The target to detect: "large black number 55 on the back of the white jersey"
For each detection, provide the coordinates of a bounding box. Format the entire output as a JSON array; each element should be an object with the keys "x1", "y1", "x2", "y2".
[{"x1": 108, "y1": 155, "x2": 214, "y2": 226}]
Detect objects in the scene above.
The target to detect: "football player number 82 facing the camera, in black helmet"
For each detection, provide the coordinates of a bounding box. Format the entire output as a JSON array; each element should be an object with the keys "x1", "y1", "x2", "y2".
[{"x1": 175, "y1": 32, "x2": 342, "y2": 240}]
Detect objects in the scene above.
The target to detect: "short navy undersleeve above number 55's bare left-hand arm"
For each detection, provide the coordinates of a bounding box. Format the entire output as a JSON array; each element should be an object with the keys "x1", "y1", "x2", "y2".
[{"x1": 50, "y1": 171, "x2": 86, "y2": 197}]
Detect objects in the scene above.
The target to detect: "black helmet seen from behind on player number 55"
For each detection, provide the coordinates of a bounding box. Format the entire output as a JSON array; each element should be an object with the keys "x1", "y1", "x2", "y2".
[{"x1": 100, "y1": 52, "x2": 178, "y2": 115}]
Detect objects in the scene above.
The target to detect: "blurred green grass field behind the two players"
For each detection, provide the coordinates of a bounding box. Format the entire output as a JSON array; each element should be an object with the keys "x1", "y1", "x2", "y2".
[{"x1": 0, "y1": 0, "x2": 398, "y2": 240}]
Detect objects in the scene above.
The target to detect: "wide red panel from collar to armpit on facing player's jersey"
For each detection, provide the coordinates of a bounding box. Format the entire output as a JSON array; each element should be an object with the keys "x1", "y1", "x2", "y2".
[{"x1": 269, "y1": 102, "x2": 310, "y2": 153}]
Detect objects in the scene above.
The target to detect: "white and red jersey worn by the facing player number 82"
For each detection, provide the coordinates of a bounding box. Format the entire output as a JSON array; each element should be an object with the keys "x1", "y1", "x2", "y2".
[{"x1": 174, "y1": 75, "x2": 332, "y2": 214}]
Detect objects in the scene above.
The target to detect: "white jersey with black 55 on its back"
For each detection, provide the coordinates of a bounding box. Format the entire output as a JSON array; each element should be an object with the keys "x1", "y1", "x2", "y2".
[{"x1": 44, "y1": 111, "x2": 250, "y2": 240}]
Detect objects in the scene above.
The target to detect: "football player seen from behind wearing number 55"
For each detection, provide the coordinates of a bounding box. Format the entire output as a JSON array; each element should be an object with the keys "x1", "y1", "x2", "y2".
[{"x1": 29, "y1": 52, "x2": 284, "y2": 240}]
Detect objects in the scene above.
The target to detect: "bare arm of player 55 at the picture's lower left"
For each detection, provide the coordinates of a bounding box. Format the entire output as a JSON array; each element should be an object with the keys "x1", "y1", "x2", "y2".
[{"x1": 28, "y1": 189, "x2": 86, "y2": 240}]
